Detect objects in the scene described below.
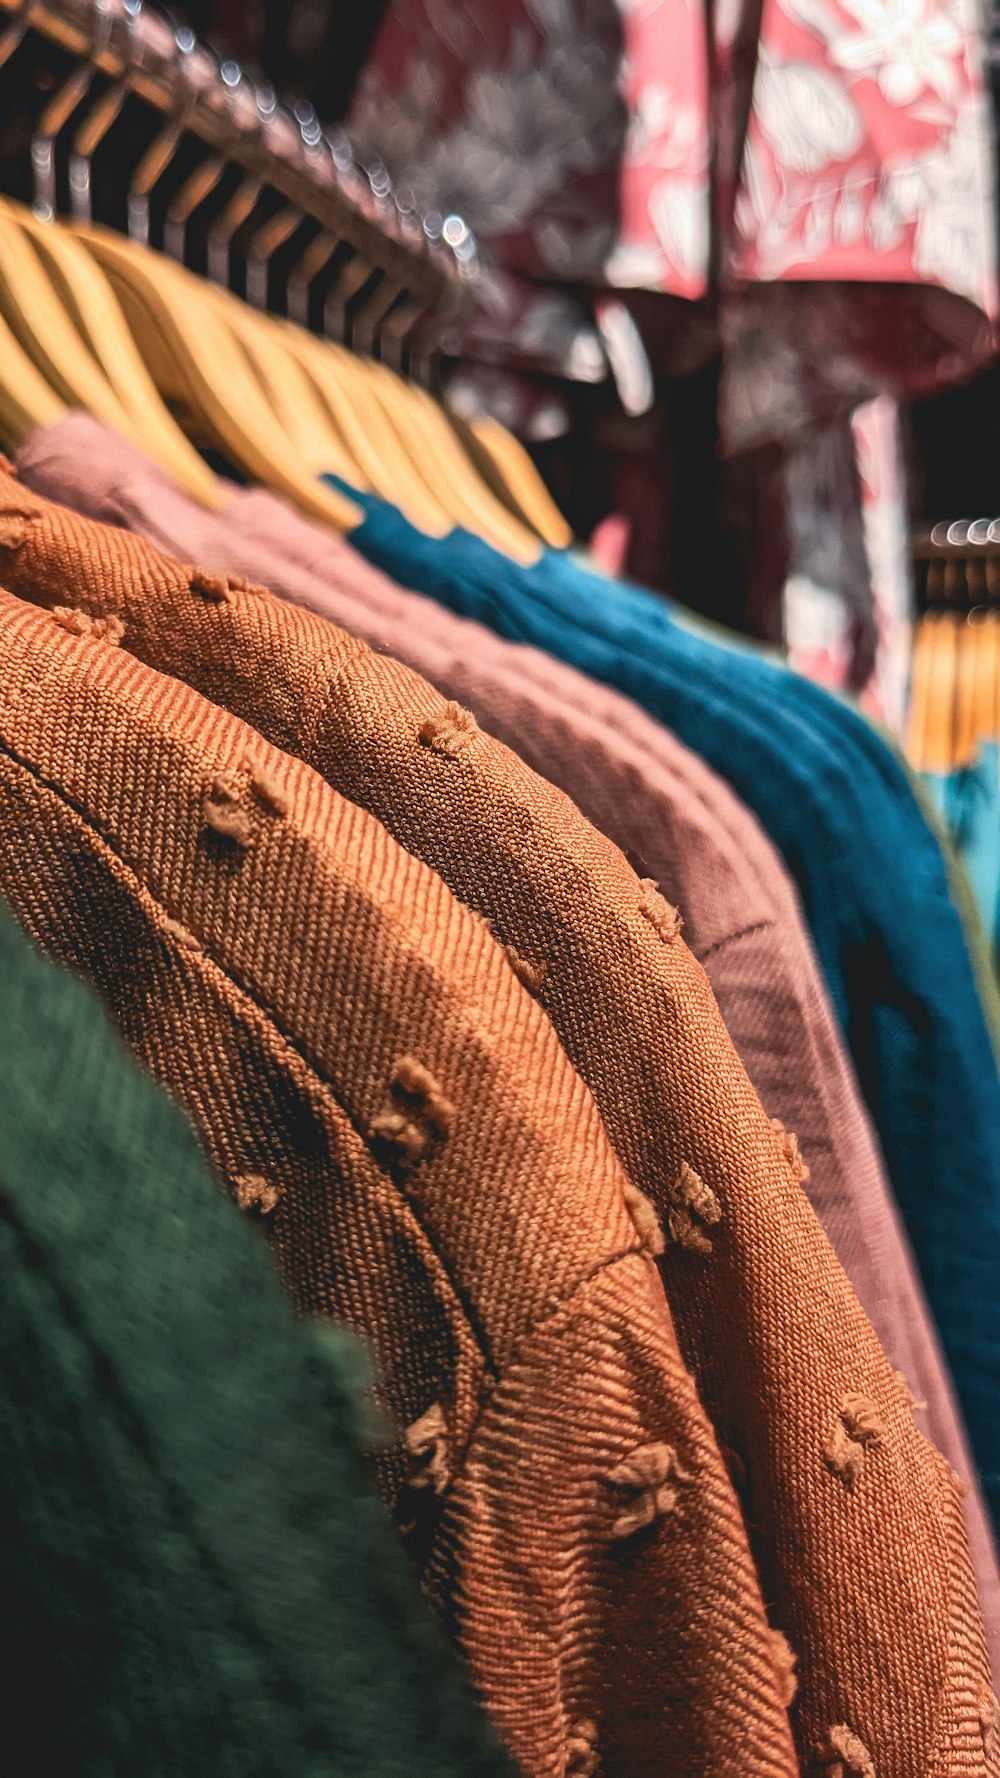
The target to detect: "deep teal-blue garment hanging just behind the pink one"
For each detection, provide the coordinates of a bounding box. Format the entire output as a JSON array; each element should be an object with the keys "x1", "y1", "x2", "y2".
[{"x1": 331, "y1": 478, "x2": 1000, "y2": 1522}]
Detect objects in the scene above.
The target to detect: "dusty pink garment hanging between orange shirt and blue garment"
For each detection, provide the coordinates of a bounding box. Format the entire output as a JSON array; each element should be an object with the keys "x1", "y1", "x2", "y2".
[{"x1": 18, "y1": 403, "x2": 1000, "y2": 1668}]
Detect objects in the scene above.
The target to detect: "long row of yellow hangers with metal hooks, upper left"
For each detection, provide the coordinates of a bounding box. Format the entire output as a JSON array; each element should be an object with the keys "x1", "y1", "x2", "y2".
[{"x1": 0, "y1": 0, "x2": 569, "y2": 562}]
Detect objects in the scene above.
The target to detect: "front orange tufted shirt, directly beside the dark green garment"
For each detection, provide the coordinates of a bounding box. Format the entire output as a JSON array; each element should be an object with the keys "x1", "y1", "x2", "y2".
[{"x1": 0, "y1": 590, "x2": 793, "y2": 1778}]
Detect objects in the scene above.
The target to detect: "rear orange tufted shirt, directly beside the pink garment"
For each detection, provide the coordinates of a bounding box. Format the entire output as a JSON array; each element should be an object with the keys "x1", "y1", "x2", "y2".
[{"x1": 4, "y1": 451, "x2": 995, "y2": 1778}]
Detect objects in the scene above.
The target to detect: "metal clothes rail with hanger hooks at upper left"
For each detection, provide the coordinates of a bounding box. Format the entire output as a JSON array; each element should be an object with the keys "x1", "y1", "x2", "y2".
[{"x1": 0, "y1": 0, "x2": 479, "y2": 373}]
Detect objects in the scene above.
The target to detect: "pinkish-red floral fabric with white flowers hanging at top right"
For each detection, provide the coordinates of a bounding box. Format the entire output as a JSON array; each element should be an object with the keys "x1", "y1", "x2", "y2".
[{"x1": 351, "y1": 0, "x2": 996, "y2": 450}]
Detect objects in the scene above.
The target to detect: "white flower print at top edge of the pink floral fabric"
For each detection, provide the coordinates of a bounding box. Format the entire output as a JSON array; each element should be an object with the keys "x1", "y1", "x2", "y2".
[{"x1": 829, "y1": 0, "x2": 966, "y2": 107}]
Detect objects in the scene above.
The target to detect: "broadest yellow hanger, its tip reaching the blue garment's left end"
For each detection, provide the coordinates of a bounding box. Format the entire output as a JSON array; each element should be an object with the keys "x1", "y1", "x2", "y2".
[{"x1": 78, "y1": 226, "x2": 363, "y2": 530}]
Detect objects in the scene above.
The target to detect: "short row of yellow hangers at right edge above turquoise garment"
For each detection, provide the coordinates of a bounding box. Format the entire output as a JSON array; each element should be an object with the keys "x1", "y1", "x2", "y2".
[{"x1": 907, "y1": 519, "x2": 1000, "y2": 772}]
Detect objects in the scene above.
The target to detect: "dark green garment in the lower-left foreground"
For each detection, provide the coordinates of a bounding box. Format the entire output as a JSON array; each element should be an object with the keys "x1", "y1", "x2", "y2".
[{"x1": 0, "y1": 909, "x2": 509, "y2": 1778}]
